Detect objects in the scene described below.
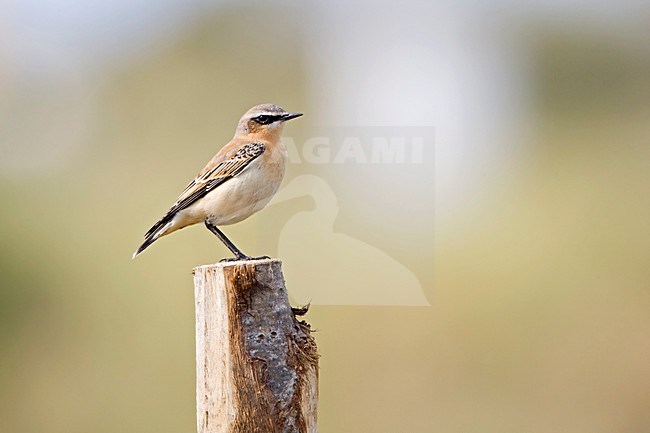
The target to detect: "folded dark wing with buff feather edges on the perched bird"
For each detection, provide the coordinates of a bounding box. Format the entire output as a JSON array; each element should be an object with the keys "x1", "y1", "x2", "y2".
[{"x1": 144, "y1": 141, "x2": 266, "y2": 238}]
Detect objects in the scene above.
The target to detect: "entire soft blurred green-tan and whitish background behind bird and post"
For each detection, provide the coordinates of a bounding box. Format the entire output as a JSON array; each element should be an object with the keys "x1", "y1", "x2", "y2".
[{"x1": 0, "y1": 0, "x2": 650, "y2": 433}]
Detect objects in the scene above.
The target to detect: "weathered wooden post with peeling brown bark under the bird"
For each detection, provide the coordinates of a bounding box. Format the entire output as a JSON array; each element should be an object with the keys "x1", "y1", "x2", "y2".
[{"x1": 194, "y1": 260, "x2": 318, "y2": 433}]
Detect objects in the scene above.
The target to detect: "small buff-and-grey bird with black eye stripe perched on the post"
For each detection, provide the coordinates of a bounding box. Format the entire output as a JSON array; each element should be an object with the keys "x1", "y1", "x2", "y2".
[{"x1": 133, "y1": 104, "x2": 302, "y2": 260}]
